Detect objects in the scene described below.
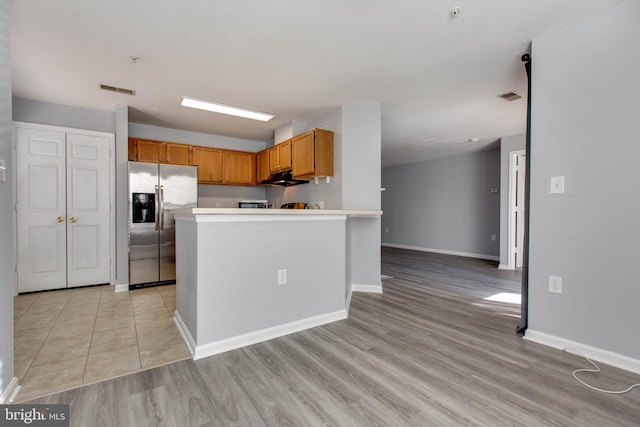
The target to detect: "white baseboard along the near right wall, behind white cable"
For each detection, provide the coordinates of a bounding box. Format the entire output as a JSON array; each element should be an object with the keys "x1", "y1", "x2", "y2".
[{"x1": 524, "y1": 329, "x2": 640, "y2": 374}]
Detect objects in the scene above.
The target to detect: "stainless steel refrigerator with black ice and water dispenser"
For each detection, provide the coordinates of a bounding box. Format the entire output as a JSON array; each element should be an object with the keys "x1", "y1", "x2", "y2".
[{"x1": 129, "y1": 162, "x2": 198, "y2": 289}]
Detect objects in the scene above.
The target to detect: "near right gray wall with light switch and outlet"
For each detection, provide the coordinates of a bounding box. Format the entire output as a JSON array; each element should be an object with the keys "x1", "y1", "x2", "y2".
[{"x1": 529, "y1": 1, "x2": 640, "y2": 359}]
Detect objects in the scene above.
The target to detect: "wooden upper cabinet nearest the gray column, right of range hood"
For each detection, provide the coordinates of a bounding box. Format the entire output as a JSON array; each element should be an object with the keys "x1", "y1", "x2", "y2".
[{"x1": 291, "y1": 129, "x2": 333, "y2": 179}]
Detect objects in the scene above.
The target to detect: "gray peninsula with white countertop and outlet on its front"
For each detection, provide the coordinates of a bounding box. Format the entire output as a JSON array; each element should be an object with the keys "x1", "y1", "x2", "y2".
[{"x1": 174, "y1": 208, "x2": 382, "y2": 359}]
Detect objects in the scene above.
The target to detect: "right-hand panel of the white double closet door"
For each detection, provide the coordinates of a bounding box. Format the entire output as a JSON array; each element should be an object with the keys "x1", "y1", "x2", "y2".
[{"x1": 67, "y1": 133, "x2": 110, "y2": 287}]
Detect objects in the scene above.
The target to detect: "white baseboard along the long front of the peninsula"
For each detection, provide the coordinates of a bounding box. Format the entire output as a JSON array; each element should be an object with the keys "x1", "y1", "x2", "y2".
[{"x1": 193, "y1": 310, "x2": 347, "y2": 360}]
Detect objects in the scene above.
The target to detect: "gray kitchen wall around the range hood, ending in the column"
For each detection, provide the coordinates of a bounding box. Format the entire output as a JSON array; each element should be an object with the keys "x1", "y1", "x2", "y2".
[{"x1": 267, "y1": 104, "x2": 382, "y2": 288}]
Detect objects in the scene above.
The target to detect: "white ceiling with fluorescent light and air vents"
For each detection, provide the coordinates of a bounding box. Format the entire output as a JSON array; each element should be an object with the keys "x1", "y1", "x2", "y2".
[{"x1": 11, "y1": 0, "x2": 621, "y2": 166}]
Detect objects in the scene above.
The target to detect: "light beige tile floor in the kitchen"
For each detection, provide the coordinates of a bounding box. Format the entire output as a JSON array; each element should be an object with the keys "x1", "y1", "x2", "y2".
[{"x1": 14, "y1": 285, "x2": 191, "y2": 402}]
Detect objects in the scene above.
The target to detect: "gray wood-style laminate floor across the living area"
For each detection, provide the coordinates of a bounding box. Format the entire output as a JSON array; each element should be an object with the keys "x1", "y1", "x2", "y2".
[{"x1": 25, "y1": 248, "x2": 640, "y2": 426}]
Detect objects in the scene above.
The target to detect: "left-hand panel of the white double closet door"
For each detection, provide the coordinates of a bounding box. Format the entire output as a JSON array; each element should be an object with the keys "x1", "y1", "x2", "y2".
[{"x1": 16, "y1": 128, "x2": 67, "y2": 292}]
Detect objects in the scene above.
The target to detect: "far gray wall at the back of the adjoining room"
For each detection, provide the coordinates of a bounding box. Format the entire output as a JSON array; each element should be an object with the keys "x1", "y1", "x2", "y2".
[{"x1": 382, "y1": 149, "x2": 500, "y2": 260}]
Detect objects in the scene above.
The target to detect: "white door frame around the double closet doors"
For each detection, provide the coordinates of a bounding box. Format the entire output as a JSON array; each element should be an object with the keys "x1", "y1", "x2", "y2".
[{"x1": 11, "y1": 121, "x2": 116, "y2": 295}]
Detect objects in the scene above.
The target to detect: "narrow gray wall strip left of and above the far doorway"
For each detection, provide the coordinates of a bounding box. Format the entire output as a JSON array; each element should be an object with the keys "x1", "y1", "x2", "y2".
[{"x1": 500, "y1": 133, "x2": 527, "y2": 266}]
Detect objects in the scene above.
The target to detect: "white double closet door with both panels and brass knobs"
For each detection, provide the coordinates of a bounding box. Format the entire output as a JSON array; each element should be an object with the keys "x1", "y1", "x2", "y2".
[{"x1": 16, "y1": 125, "x2": 113, "y2": 293}]
